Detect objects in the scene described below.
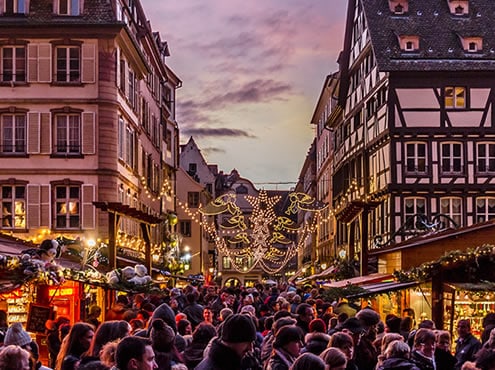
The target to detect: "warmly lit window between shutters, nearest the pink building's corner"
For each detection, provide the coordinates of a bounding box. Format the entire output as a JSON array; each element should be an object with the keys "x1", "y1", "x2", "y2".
[{"x1": 55, "y1": 185, "x2": 81, "y2": 229}]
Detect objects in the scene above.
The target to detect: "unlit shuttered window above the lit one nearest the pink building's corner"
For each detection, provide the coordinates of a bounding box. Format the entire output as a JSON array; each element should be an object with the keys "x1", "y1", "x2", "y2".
[{"x1": 55, "y1": 114, "x2": 81, "y2": 154}]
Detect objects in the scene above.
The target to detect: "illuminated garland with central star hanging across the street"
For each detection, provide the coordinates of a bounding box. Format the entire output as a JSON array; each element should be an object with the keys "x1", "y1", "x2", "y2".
[{"x1": 200, "y1": 190, "x2": 325, "y2": 274}]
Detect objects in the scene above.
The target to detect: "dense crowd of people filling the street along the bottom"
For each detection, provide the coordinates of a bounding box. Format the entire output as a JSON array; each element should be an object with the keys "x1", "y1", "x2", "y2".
[{"x1": 0, "y1": 284, "x2": 495, "y2": 370}]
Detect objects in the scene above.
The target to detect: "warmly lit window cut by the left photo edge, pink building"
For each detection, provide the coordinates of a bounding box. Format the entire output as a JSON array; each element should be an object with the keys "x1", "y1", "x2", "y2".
[{"x1": 1, "y1": 185, "x2": 26, "y2": 229}]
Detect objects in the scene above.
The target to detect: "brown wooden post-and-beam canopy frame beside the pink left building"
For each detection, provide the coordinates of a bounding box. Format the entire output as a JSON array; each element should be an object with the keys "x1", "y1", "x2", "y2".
[{"x1": 93, "y1": 202, "x2": 164, "y2": 273}]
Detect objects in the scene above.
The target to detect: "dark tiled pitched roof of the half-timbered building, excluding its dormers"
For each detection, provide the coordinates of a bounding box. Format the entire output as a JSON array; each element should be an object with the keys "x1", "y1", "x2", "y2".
[{"x1": 360, "y1": 0, "x2": 495, "y2": 72}]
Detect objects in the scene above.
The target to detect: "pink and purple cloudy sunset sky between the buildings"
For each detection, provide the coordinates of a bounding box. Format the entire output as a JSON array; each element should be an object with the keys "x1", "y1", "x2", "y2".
[{"x1": 142, "y1": 0, "x2": 346, "y2": 189}]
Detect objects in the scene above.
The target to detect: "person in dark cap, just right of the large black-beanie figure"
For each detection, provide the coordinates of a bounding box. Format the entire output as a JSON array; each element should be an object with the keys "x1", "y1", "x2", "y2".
[{"x1": 266, "y1": 325, "x2": 303, "y2": 370}]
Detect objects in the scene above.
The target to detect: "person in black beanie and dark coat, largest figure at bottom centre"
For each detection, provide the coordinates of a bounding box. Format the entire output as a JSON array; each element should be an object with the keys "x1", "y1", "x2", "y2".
[{"x1": 195, "y1": 314, "x2": 256, "y2": 370}]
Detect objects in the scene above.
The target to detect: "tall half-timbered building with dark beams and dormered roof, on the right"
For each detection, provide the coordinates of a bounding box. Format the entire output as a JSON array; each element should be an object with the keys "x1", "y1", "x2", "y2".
[{"x1": 327, "y1": 0, "x2": 495, "y2": 273}]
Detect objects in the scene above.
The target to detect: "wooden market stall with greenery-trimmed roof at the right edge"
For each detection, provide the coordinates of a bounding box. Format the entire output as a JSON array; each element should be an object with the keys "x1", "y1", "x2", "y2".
[{"x1": 370, "y1": 220, "x2": 495, "y2": 333}]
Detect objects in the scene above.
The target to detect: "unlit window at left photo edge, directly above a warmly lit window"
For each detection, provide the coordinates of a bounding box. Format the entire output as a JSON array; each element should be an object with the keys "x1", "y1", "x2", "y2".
[{"x1": 1, "y1": 114, "x2": 26, "y2": 153}]
